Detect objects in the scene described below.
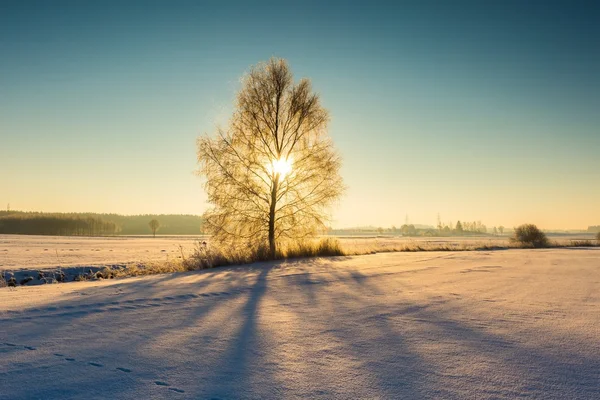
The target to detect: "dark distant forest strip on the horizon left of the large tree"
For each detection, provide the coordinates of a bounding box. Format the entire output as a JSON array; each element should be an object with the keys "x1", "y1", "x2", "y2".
[{"x1": 0, "y1": 211, "x2": 202, "y2": 236}]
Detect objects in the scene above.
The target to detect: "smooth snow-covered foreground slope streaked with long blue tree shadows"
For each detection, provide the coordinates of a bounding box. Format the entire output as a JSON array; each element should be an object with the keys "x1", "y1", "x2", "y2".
[{"x1": 0, "y1": 248, "x2": 600, "y2": 399}]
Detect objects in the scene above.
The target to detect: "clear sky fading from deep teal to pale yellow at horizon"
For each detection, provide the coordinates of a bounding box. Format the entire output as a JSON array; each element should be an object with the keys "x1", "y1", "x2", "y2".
[{"x1": 0, "y1": 0, "x2": 600, "y2": 229}]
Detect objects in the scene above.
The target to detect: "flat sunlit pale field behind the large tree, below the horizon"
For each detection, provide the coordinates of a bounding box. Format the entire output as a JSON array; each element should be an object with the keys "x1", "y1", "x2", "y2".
[{"x1": 0, "y1": 234, "x2": 594, "y2": 271}]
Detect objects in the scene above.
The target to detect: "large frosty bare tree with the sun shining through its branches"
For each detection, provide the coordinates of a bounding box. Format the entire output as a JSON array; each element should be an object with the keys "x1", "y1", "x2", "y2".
[{"x1": 198, "y1": 58, "x2": 344, "y2": 257}]
